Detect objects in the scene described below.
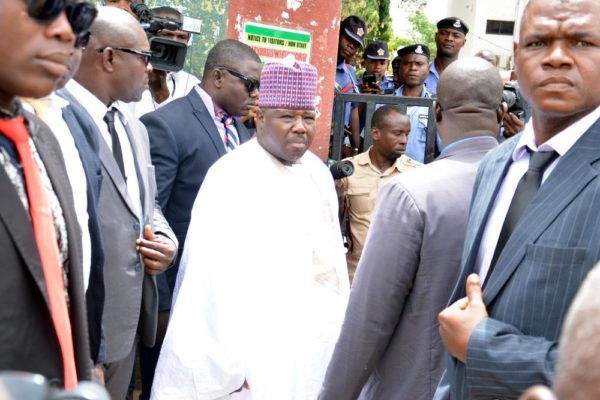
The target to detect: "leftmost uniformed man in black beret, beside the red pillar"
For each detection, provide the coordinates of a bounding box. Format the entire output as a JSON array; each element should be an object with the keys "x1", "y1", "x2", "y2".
[{"x1": 334, "y1": 15, "x2": 367, "y2": 154}]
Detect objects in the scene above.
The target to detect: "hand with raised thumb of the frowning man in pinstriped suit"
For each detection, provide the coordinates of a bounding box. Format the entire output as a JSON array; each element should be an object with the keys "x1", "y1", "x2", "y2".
[{"x1": 438, "y1": 274, "x2": 488, "y2": 363}]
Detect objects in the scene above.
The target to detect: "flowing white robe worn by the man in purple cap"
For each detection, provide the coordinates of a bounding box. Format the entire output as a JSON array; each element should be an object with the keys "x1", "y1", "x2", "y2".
[{"x1": 152, "y1": 139, "x2": 349, "y2": 400}]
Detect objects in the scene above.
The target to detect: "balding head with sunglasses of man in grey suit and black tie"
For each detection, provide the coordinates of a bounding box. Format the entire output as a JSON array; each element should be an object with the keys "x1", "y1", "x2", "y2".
[{"x1": 75, "y1": 7, "x2": 150, "y2": 106}]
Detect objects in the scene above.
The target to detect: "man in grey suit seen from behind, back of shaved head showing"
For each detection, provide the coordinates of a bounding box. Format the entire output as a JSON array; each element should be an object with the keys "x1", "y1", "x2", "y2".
[{"x1": 319, "y1": 58, "x2": 505, "y2": 400}]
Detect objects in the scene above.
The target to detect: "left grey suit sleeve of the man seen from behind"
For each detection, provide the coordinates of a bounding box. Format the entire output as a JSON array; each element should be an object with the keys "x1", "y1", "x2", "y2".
[{"x1": 319, "y1": 182, "x2": 424, "y2": 400}]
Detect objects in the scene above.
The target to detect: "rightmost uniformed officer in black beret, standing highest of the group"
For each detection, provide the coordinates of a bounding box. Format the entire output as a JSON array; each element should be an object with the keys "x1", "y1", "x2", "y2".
[{"x1": 425, "y1": 17, "x2": 469, "y2": 95}]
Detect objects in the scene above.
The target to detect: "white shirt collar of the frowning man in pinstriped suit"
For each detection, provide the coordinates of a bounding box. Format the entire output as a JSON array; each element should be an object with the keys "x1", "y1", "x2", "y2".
[{"x1": 512, "y1": 106, "x2": 600, "y2": 161}]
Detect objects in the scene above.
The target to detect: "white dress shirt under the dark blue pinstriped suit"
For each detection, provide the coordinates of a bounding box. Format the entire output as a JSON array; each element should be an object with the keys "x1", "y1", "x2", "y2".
[{"x1": 475, "y1": 107, "x2": 600, "y2": 282}]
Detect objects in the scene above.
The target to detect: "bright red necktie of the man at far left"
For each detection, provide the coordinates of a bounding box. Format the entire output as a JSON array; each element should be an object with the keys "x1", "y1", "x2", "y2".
[{"x1": 0, "y1": 116, "x2": 77, "y2": 389}]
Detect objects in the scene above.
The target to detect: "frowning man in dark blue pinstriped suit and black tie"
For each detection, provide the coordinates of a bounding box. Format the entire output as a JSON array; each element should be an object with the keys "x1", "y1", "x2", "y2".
[{"x1": 435, "y1": 0, "x2": 600, "y2": 400}]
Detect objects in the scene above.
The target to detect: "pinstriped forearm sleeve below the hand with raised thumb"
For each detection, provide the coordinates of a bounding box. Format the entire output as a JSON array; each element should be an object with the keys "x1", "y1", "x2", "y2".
[{"x1": 467, "y1": 318, "x2": 558, "y2": 398}]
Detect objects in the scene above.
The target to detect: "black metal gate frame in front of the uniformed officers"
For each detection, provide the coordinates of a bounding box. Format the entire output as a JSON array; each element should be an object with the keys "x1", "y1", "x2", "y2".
[{"x1": 331, "y1": 93, "x2": 437, "y2": 163}]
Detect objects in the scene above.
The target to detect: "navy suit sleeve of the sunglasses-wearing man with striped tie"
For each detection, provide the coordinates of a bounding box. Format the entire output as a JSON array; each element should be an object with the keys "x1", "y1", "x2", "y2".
[{"x1": 140, "y1": 112, "x2": 179, "y2": 208}]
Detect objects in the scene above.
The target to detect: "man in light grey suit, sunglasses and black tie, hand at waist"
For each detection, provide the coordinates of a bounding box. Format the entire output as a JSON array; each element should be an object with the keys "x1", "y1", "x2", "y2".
[{"x1": 66, "y1": 7, "x2": 177, "y2": 400}]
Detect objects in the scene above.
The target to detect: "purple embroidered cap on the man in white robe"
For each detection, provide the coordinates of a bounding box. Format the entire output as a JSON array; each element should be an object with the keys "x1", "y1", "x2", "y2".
[{"x1": 258, "y1": 57, "x2": 317, "y2": 110}]
